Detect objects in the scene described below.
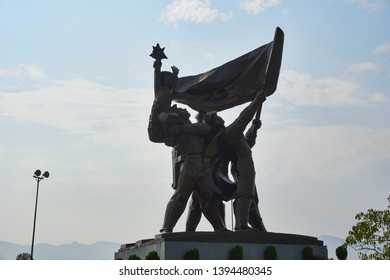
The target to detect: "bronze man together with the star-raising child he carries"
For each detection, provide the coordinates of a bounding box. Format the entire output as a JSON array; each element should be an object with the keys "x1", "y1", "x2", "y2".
[{"x1": 148, "y1": 44, "x2": 226, "y2": 233}]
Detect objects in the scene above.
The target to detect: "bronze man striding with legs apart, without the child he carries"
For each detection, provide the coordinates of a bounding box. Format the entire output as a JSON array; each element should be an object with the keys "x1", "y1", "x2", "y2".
[{"x1": 160, "y1": 107, "x2": 226, "y2": 233}]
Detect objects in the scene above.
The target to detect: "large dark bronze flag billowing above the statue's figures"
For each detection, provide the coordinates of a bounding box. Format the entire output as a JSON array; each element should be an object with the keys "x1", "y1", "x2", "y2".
[{"x1": 173, "y1": 27, "x2": 284, "y2": 112}]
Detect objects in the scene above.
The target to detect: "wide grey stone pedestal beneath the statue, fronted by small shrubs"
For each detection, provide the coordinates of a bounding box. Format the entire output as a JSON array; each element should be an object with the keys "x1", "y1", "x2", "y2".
[{"x1": 115, "y1": 231, "x2": 328, "y2": 260}]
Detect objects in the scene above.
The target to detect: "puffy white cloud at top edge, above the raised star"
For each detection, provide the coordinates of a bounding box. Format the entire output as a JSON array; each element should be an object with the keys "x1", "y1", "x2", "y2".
[{"x1": 161, "y1": 0, "x2": 232, "y2": 25}]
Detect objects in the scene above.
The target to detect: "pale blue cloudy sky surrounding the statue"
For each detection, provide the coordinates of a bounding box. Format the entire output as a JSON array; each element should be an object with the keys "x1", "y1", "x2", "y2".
[{"x1": 0, "y1": 0, "x2": 390, "y2": 244}]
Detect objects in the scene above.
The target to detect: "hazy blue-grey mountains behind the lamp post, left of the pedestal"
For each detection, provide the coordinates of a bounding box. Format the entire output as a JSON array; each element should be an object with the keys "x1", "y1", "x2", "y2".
[{"x1": 0, "y1": 241, "x2": 121, "y2": 260}]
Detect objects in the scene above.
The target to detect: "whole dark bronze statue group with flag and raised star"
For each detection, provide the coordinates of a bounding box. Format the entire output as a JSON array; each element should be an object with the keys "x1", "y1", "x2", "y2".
[{"x1": 148, "y1": 28, "x2": 284, "y2": 233}]
